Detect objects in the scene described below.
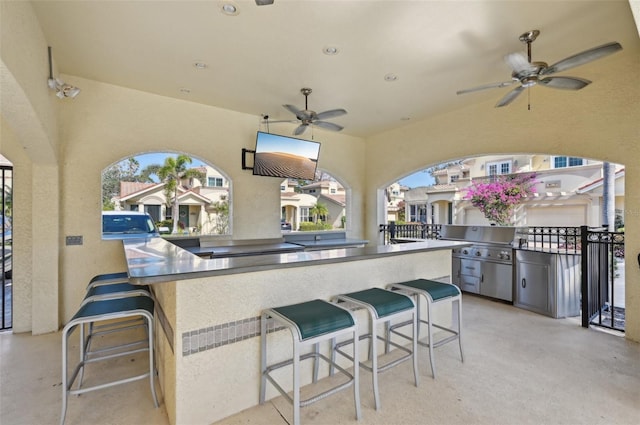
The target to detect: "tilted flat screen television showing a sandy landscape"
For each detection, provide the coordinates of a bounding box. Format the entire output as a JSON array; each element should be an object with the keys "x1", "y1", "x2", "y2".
[{"x1": 253, "y1": 131, "x2": 320, "y2": 180}]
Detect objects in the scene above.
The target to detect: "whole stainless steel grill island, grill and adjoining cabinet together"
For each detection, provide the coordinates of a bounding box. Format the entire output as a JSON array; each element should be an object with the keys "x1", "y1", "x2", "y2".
[{"x1": 440, "y1": 225, "x2": 581, "y2": 318}]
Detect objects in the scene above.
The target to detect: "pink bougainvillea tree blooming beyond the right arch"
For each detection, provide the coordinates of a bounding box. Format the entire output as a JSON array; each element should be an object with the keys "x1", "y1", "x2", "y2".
[{"x1": 464, "y1": 173, "x2": 537, "y2": 226}]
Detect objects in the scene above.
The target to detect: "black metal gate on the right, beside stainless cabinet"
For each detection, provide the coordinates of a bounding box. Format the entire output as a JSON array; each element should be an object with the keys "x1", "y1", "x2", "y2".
[{"x1": 580, "y1": 226, "x2": 625, "y2": 332}]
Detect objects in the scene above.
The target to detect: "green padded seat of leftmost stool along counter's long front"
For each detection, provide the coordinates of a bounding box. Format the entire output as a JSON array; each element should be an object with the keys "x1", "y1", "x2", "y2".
[{"x1": 273, "y1": 300, "x2": 355, "y2": 340}]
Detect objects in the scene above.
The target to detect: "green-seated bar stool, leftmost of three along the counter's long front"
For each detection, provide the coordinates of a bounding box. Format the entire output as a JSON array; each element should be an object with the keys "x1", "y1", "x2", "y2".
[{"x1": 260, "y1": 300, "x2": 360, "y2": 425}]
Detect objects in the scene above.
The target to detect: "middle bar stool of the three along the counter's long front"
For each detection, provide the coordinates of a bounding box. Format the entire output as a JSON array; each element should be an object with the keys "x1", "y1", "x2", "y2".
[{"x1": 330, "y1": 288, "x2": 418, "y2": 410}]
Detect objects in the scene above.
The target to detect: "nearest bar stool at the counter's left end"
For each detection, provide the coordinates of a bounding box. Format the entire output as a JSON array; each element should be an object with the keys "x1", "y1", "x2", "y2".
[{"x1": 60, "y1": 295, "x2": 158, "y2": 425}]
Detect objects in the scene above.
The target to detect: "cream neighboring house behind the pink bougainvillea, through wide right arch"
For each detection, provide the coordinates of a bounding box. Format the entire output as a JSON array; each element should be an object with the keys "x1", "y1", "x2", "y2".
[{"x1": 405, "y1": 155, "x2": 624, "y2": 226}]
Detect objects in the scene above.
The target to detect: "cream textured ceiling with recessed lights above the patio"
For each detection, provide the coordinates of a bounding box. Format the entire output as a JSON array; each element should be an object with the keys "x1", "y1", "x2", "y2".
[{"x1": 33, "y1": 0, "x2": 638, "y2": 136}]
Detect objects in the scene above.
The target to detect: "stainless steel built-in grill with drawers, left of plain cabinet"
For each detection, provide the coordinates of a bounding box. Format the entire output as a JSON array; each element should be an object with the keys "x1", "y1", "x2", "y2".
[{"x1": 440, "y1": 225, "x2": 516, "y2": 302}]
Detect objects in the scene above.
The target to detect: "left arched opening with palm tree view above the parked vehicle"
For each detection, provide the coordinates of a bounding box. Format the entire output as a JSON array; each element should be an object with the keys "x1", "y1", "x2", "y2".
[{"x1": 102, "y1": 152, "x2": 232, "y2": 235}]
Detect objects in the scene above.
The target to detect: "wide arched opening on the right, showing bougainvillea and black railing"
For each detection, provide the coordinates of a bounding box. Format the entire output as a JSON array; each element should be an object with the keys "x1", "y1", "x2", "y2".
[{"x1": 379, "y1": 154, "x2": 625, "y2": 330}]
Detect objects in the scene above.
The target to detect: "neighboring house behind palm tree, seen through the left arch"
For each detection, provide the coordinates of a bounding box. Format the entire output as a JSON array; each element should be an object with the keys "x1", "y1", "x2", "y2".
[{"x1": 114, "y1": 166, "x2": 229, "y2": 234}]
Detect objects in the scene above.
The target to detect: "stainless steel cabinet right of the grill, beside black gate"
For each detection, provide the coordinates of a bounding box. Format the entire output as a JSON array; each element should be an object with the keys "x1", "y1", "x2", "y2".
[{"x1": 513, "y1": 250, "x2": 580, "y2": 318}]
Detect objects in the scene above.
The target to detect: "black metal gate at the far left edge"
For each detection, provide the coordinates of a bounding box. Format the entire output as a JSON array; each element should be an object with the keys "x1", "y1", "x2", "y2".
[{"x1": 0, "y1": 165, "x2": 13, "y2": 330}]
